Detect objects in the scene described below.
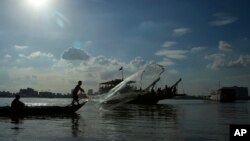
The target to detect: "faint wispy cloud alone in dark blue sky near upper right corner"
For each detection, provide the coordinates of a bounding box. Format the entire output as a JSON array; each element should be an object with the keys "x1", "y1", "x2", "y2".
[{"x1": 210, "y1": 13, "x2": 238, "y2": 26}]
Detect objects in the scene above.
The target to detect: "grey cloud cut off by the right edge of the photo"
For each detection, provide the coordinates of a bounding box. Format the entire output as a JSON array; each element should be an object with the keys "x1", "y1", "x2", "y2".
[{"x1": 228, "y1": 55, "x2": 250, "y2": 67}]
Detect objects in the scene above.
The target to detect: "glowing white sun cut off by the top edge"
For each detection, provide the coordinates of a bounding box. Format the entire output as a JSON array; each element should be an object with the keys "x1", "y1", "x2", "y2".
[{"x1": 26, "y1": 0, "x2": 49, "y2": 10}]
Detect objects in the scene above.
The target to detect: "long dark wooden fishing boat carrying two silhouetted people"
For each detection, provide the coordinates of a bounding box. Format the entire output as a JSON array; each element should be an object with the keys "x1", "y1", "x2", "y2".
[{"x1": 0, "y1": 101, "x2": 87, "y2": 116}]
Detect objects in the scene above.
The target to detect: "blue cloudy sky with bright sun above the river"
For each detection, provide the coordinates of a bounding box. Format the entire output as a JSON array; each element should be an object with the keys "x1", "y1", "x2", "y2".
[{"x1": 0, "y1": 0, "x2": 250, "y2": 95}]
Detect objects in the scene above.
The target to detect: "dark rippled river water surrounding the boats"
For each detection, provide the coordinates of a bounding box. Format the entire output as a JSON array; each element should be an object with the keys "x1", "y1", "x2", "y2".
[{"x1": 0, "y1": 98, "x2": 250, "y2": 141}]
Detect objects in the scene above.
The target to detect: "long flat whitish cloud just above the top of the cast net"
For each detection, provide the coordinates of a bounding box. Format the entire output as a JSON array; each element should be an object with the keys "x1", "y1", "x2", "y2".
[{"x1": 155, "y1": 50, "x2": 188, "y2": 59}]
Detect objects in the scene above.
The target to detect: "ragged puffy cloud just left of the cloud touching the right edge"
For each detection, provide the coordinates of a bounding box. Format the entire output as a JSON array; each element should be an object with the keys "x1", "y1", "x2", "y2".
[{"x1": 204, "y1": 53, "x2": 226, "y2": 70}]
